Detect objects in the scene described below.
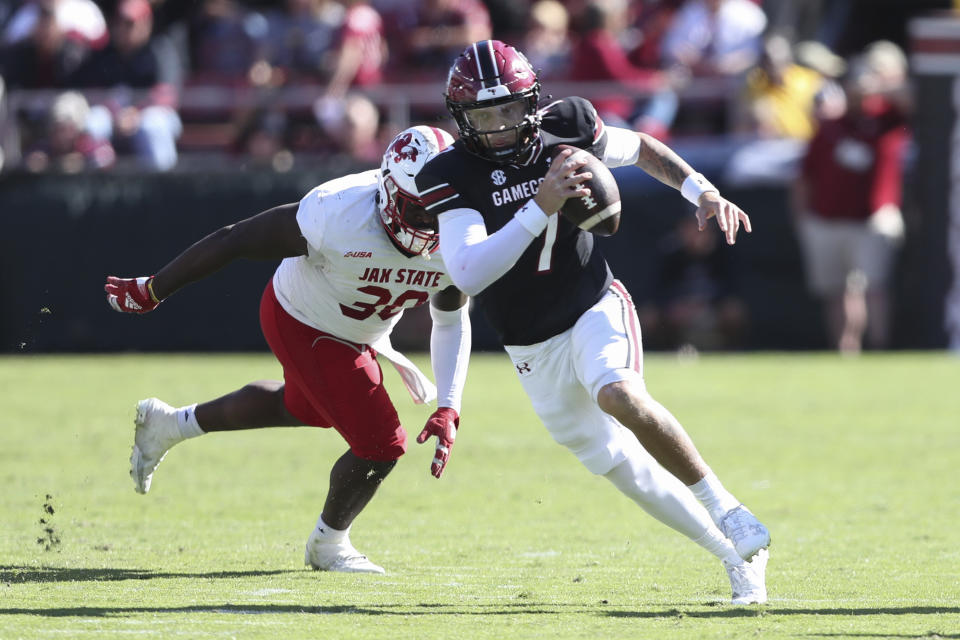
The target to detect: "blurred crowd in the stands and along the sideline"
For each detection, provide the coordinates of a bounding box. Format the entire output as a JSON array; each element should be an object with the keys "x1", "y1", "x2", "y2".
[{"x1": 0, "y1": 0, "x2": 960, "y2": 353}]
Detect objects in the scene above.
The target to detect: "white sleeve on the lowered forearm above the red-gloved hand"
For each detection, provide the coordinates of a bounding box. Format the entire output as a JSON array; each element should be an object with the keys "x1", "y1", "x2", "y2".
[{"x1": 430, "y1": 302, "x2": 472, "y2": 414}]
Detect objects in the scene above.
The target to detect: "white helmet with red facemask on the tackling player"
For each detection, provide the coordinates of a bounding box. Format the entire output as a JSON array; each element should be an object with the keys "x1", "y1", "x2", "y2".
[{"x1": 379, "y1": 125, "x2": 453, "y2": 255}]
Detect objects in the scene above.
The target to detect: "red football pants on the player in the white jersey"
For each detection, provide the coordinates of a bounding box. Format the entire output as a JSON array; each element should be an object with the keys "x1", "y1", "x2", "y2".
[{"x1": 260, "y1": 280, "x2": 407, "y2": 461}]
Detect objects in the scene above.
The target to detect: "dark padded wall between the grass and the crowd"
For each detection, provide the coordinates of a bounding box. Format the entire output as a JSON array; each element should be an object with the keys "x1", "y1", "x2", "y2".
[{"x1": 0, "y1": 162, "x2": 946, "y2": 353}]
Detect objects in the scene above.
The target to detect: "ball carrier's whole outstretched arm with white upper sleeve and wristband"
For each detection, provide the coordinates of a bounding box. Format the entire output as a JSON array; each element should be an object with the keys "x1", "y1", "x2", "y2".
[{"x1": 602, "y1": 127, "x2": 753, "y2": 244}]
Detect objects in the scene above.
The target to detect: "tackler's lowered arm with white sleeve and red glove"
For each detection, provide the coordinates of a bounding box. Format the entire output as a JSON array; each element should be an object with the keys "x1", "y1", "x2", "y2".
[{"x1": 417, "y1": 286, "x2": 471, "y2": 478}]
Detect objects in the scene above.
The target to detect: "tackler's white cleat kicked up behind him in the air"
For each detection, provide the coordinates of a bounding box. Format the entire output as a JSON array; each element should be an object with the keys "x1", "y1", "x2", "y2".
[{"x1": 130, "y1": 398, "x2": 183, "y2": 493}]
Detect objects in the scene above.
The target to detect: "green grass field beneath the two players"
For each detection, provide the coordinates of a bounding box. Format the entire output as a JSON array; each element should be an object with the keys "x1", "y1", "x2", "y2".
[{"x1": 0, "y1": 354, "x2": 960, "y2": 640}]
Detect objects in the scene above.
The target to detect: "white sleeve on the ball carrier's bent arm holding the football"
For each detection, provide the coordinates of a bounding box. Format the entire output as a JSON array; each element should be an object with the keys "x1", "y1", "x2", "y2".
[{"x1": 438, "y1": 200, "x2": 547, "y2": 296}]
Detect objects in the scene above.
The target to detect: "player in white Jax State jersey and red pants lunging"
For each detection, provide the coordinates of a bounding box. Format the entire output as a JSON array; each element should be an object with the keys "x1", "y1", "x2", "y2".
[{"x1": 105, "y1": 126, "x2": 470, "y2": 573}]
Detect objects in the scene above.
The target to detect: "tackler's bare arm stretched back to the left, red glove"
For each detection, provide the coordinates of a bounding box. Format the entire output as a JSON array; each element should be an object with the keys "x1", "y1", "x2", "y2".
[{"x1": 104, "y1": 203, "x2": 307, "y2": 313}]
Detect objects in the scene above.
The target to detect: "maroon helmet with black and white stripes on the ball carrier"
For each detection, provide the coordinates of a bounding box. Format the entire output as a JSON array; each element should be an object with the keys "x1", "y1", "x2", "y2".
[{"x1": 444, "y1": 40, "x2": 540, "y2": 164}]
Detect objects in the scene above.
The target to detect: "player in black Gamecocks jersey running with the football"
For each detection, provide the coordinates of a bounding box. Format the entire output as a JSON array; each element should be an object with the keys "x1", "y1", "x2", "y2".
[{"x1": 417, "y1": 40, "x2": 770, "y2": 604}]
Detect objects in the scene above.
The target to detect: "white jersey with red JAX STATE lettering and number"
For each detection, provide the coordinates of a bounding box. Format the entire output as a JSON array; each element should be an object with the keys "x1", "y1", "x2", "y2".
[{"x1": 273, "y1": 170, "x2": 452, "y2": 344}]
